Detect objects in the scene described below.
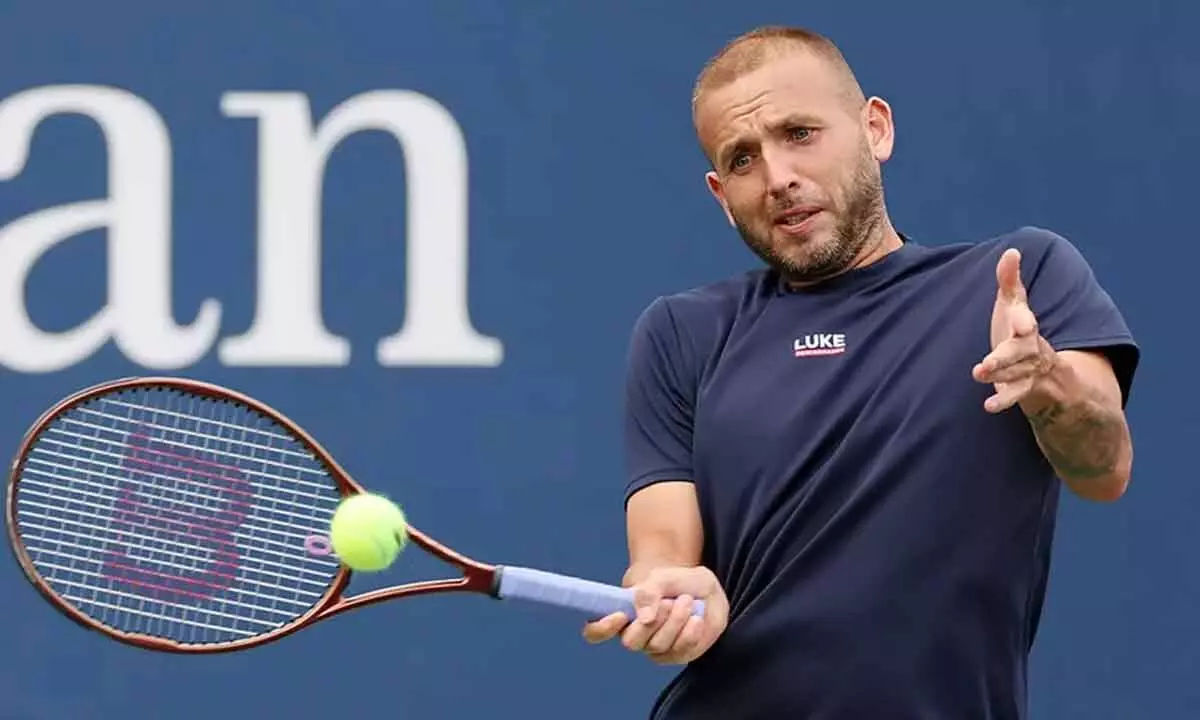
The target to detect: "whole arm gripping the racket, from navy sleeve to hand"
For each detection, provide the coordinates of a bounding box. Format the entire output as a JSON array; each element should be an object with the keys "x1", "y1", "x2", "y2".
[{"x1": 583, "y1": 299, "x2": 728, "y2": 664}]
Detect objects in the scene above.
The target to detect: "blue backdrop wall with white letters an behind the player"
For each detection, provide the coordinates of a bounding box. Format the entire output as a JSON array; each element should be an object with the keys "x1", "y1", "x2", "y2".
[{"x1": 0, "y1": 0, "x2": 1200, "y2": 720}]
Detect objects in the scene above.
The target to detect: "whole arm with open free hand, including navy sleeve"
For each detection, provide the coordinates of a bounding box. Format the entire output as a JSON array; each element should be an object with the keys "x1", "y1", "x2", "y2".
[{"x1": 972, "y1": 233, "x2": 1139, "y2": 502}]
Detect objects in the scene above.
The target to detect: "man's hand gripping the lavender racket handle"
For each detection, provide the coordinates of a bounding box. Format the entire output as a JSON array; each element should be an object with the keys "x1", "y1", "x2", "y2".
[{"x1": 583, "y1": 566, "x2": 730, "y2": 665}]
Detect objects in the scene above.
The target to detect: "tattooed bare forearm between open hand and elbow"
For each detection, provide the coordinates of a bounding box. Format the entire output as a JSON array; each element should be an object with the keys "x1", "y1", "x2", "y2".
[{"x1": 1021, "y1": 353, "x2": 1133, "y2": 500}]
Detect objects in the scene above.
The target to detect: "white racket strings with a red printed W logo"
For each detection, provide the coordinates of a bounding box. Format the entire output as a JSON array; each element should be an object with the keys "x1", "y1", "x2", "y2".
[{"x1": 16, "y1": 389, "x2": 340, "y2": 643}]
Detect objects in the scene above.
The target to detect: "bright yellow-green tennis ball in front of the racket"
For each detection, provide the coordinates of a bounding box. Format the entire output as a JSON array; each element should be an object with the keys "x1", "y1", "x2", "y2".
[{"x1": 329, "y1": 493, "x2": 408, "y2": 572}]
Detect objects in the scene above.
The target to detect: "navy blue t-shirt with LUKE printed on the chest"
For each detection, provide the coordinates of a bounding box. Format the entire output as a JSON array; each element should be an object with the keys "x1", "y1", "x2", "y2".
[{"x1": 625, "y1": 228, "x2": 1138, "y2": 720}]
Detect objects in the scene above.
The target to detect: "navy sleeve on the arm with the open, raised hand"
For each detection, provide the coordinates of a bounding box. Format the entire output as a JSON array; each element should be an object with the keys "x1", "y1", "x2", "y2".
[{"x1": 1022, "y1": 230, "x2": 1140, "y2": 404}]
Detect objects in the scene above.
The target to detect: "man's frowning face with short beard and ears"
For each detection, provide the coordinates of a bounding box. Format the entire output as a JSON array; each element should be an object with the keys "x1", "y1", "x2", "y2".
[{"x1": 696, "y1": 49, "x2": 892, "y2": 281}]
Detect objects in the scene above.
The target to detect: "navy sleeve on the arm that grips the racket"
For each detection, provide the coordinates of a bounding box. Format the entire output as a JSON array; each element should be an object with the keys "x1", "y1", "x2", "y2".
[{"x1": 624, "y1": 298, "x2": 696, "y2": 503}]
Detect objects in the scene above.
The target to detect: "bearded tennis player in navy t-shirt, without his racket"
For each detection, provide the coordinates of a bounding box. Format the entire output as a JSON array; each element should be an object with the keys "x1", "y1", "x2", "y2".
[{"x1": 584, "y1": 28, "x2": 1139, "y2": 720}]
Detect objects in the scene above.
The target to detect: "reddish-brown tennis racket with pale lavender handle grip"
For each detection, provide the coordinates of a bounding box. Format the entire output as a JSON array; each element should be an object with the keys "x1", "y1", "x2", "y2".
[{"x1": 6, "y1": 378, "x2": 703, "y2": 653}]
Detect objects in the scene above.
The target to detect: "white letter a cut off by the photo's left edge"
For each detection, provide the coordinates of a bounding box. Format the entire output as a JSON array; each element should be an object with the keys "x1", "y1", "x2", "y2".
[{"x1": 0, "y1": 85, "x2": 221, "y2": 372}]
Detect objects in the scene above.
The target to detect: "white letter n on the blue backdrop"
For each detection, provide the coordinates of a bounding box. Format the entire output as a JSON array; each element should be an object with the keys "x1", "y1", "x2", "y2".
[{"x1": 220, "y1": 90, "x2": 503, "y2": 367}]
